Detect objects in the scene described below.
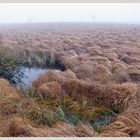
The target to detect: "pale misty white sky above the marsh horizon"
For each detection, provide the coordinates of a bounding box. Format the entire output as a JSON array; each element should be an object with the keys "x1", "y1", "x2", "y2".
[{"x1": 0, "y1": 3, "x2": 140, "y2": 24}]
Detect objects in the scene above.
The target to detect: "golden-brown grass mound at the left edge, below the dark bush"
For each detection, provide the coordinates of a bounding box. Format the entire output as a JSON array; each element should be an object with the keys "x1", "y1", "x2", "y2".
[{"x1": 0, "y1": 79, "x2": 20, "y2": 132}]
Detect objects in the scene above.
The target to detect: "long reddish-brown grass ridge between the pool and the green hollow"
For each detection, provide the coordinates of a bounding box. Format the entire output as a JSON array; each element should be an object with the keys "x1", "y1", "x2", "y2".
[{"x1": 34, "y1": 71, "x2": 137, "y2": 111}]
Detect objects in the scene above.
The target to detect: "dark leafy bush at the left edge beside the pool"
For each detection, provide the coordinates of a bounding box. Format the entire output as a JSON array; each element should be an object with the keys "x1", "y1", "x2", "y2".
[{"x1": 0, "y1": 43, "x2": 24, "y2": 84}]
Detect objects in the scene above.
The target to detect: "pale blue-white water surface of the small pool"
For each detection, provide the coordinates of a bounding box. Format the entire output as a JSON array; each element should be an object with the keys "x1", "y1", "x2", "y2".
[{"x1": 18, "y1": 67, "x2": 45, "y2": 87}]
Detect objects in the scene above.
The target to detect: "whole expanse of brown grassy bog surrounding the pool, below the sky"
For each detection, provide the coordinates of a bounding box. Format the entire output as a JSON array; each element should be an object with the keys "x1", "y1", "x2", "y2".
[{"x1": 0, "y1": 23, "x2": 140, "y2": 136}]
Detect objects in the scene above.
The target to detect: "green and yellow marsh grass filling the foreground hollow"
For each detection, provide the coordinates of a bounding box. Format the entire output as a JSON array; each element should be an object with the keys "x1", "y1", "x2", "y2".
[{"x1": 21, "y1": 85, "x2": 116, "y2": 131}]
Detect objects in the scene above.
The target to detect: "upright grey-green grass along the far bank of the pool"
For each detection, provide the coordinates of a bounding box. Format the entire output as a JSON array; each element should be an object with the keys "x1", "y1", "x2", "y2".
[{"x1": 14, "y1": 48, "x2": 66, "y2": 71}]
